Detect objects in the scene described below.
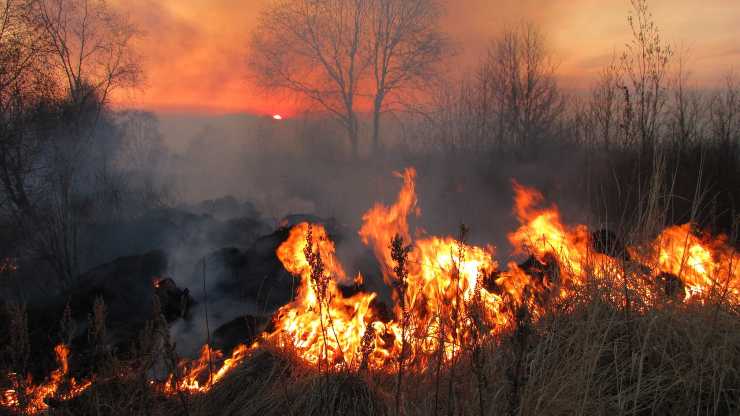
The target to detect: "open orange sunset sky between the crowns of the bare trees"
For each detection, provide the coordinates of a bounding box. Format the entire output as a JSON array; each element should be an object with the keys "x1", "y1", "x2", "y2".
[{"x1": 115, "y1": 0, "x2": 740, "y2": 115}]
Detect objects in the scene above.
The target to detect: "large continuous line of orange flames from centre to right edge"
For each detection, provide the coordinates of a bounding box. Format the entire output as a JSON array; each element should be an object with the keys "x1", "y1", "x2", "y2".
[{"x1": 270, "y1": 169, "x2": 740, "y2": 369}]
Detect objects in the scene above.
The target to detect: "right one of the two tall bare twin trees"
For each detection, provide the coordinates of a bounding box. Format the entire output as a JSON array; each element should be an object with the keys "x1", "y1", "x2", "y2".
[{"x1": 367, "y1": 0, "x2": 447, "y2": 154}]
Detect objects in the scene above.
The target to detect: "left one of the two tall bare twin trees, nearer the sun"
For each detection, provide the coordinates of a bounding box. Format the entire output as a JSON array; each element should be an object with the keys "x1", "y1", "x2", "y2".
[{"x1": 249, "y1": 0, "x2": 368, "y2": 157}]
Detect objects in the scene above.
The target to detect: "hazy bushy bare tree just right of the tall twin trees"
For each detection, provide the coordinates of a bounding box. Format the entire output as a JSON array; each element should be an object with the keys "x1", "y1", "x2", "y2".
[{"x1": 414, "y1": 24, "x2": 569, "y2": 155}]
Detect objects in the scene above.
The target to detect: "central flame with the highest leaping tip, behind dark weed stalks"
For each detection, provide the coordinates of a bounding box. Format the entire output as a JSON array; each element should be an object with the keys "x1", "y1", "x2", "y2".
[{"x1": 359, "y1": 169, "x2": 502, "y2": 362}]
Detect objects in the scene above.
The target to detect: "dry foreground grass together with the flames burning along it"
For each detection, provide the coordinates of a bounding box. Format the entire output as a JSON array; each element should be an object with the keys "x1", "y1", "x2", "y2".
[{"x1": 3, "y1": 169, "x2": 740, "y2": 415}]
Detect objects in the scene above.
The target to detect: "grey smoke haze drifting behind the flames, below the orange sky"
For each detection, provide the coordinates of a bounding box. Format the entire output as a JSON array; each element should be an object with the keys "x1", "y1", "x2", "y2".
[{"x1": 0, "y1": 101, "x2": 596, "y2": 356}]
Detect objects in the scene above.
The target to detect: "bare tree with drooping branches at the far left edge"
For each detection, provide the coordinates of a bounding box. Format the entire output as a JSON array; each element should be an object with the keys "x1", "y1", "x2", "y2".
[{"x1": 0, "y1": 0, "x2": 140, "y2": 282}]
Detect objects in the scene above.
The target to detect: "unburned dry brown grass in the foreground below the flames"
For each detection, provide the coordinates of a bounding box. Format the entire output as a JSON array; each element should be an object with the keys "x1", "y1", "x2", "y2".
[{"x1": 140, "y1": 282, "x2": 740, "y2": 416}]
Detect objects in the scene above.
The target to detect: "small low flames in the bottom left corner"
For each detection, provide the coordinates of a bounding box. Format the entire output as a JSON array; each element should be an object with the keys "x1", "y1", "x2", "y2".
[{"x1": 0, "y1": 344, "x2": 92, "y2": 414}]
